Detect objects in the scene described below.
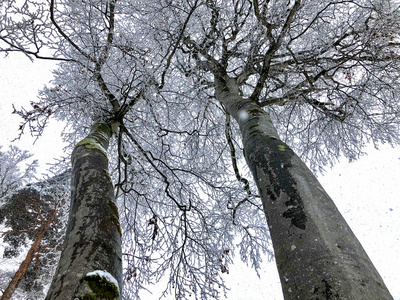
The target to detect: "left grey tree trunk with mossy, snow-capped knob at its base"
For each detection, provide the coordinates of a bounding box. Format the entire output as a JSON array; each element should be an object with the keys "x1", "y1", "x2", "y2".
[{"x1": 46, "y1": 122, "x2": 122, "y2": 300}]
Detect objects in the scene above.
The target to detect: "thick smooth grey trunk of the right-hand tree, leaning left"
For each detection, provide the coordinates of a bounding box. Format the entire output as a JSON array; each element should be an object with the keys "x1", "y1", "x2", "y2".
[{"x1": 215, "y1": 77, "x2": 393, "y2": 300}]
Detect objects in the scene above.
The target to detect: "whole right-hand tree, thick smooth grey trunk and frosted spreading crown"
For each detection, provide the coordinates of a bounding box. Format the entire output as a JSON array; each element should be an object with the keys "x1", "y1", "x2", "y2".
[{"x1": 136, "y1": 0, "x2": 400, "y2": 299}]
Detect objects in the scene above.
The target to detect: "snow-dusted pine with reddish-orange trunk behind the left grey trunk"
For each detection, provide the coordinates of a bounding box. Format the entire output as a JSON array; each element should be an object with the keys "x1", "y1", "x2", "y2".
[{"x1": 0, "y1": 156, "x2": 69, "y2": 299}]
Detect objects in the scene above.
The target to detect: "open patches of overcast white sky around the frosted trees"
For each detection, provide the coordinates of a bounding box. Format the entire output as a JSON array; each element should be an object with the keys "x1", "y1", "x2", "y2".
[{"x1": 0, "y1": 55, "x2": 400, "y2": 300}]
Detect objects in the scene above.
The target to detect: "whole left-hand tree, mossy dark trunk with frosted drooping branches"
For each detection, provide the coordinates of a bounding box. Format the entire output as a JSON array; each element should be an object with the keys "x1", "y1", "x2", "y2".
[{"x1": 1, "y1": 1, "x2": 256, "y2": 299}]
